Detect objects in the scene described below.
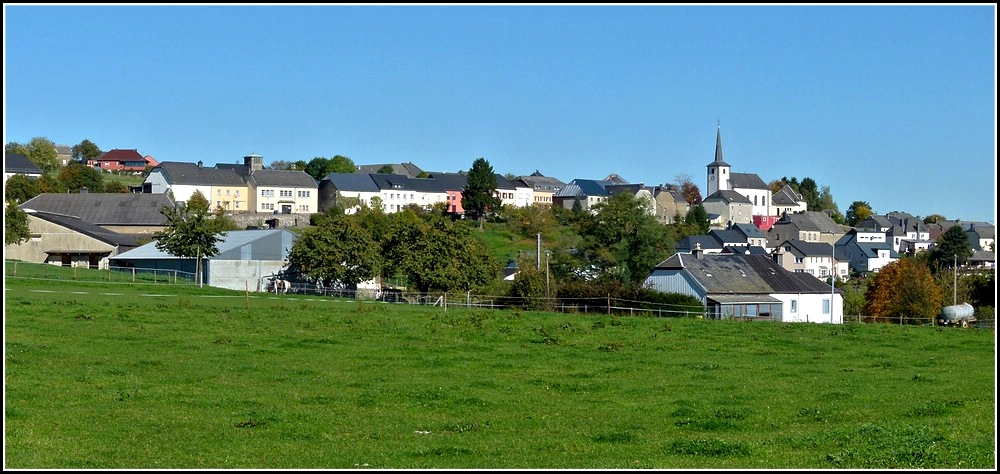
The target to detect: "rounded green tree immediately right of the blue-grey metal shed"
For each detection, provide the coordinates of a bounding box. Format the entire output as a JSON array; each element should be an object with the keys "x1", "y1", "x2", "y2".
[{"x1": 288, "y1": 214, "x2": 382, "y2": 286}]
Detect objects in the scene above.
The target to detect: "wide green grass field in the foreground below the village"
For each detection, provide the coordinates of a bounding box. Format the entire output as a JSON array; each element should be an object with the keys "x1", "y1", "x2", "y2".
[{"x1": 4, "y1": 274, "x2": 996, "y2": 469}]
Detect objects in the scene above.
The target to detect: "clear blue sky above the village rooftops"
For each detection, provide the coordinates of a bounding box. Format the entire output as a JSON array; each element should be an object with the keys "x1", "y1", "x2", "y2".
[{"x1": 3, "y1": 4, "x2": 997, "y2": 223}]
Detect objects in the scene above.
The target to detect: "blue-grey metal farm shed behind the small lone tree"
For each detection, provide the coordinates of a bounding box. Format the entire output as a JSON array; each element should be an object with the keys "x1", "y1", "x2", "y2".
[{"x1": 110, "y1": 229, "x2": 298, "y2": 291}]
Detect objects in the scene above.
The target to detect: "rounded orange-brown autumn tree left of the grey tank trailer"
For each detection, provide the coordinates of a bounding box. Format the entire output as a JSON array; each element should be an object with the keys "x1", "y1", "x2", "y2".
[{"x1": 865, "y1": 258, "x2": 944, "y2": 324}]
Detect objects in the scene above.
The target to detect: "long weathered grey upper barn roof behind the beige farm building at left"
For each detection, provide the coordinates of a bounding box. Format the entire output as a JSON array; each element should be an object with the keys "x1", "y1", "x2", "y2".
[{"x1": 19, "y1": 193, "x2": 175, "y2": 226}]
